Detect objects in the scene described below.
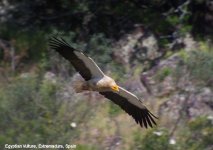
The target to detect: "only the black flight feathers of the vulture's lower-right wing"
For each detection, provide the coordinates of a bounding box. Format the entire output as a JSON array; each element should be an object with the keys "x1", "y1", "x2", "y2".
[{"x1": 100, "y1": 92, "x2": 157, "y2": 128}]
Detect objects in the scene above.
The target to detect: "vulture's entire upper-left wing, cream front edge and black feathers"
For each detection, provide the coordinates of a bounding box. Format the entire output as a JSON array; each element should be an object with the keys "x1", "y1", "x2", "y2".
[{"x1": 49, "y1": 36, "x2": 104, "y2": 81}]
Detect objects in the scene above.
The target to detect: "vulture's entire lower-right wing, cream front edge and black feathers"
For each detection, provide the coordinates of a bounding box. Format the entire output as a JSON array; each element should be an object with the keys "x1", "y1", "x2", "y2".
[{"x1": 100, "y1": 87, "x2": 157, "y2": 128}]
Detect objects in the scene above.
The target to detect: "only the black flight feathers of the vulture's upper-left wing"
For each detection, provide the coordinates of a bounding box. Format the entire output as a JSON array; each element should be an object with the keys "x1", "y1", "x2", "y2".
[{"x1": 49, "y1": 36, "x2": 92, "y2": 81}]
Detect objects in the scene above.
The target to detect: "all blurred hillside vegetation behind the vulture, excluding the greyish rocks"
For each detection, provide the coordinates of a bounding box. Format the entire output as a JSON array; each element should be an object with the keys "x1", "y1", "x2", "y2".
[{"x1": 0, "y1": 0, "x2": 213, "y2": 150}]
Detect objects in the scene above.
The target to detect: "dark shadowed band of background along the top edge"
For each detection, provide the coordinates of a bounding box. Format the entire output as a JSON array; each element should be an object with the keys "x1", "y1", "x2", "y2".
[{"x1": 1, "y1": 0, "x2": 213, "y2": 39}]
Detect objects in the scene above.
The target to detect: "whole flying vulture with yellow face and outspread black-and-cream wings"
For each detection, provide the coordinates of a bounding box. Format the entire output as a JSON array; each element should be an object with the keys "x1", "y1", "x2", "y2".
[{"x1": 49, "y1": 36, "x2": 157, "y2": 128}]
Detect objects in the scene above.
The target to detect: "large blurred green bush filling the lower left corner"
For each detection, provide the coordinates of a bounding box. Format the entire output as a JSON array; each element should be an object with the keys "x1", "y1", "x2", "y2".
[{"x1": 0, "y1": 74, "x2": 78, "y2": 145}]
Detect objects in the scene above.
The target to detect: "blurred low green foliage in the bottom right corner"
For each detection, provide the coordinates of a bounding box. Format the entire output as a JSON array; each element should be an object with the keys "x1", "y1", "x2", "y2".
[{"x1": 132, "y1": 116, "x2": 213, "y2": 150}]
